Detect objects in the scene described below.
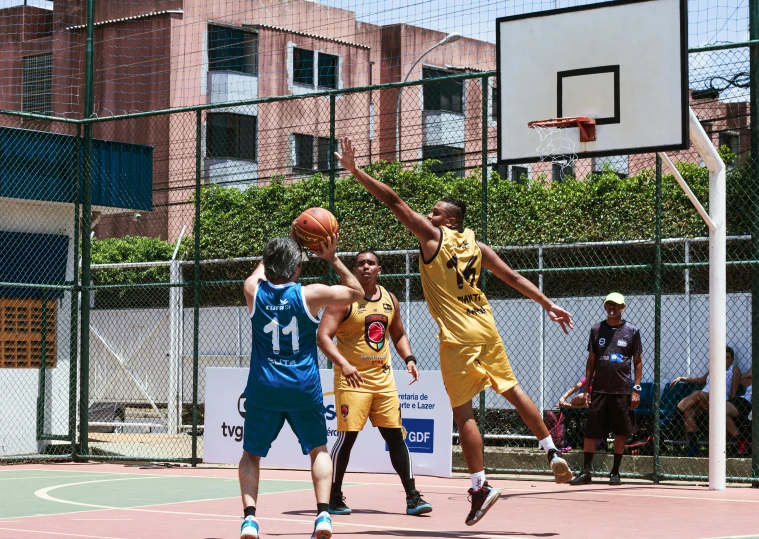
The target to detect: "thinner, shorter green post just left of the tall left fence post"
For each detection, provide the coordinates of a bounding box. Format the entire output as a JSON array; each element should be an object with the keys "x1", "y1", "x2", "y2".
[{"x1": 69, "y1": 124, "x2": 82, "y2": 460}]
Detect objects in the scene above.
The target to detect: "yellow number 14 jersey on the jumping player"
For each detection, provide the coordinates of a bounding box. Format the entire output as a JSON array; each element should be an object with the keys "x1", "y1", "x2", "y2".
[{"x1": 419, "y1": 226, "x2": 500, "y2": 345}]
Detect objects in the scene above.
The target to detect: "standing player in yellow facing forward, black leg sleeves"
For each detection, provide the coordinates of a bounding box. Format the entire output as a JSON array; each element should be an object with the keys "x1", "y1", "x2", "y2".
[{"x1": 317, "y1": 250, "x2": 432, "y2": 515}]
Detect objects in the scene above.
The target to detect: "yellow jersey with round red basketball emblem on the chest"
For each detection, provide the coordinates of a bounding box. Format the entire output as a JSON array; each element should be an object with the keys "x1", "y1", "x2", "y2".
[{"x1": 334, "y1": 286, "x2": 396, "y2": 393}]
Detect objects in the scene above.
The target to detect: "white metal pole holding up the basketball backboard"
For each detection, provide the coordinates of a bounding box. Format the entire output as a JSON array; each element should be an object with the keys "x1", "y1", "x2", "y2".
[{"x1": 690, "y1": 109, "x2": 727, "y2": 490}]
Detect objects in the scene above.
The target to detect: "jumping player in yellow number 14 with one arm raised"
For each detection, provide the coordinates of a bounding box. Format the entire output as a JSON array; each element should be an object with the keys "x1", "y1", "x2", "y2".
[{"x1": 335, "y1": 137, "x2": 574, "y2": 526}]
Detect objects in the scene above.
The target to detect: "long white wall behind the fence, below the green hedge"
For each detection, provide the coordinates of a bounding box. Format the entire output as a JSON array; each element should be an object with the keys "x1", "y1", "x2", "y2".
[{"x1": 80, "y1": 294, "x2": 751, "y2": 416}]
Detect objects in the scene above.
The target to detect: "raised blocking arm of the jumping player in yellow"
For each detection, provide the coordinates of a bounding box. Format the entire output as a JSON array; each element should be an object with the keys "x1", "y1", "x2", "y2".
[{"x1": 335, "y1": 137, "x2": 440, "y2": 251}]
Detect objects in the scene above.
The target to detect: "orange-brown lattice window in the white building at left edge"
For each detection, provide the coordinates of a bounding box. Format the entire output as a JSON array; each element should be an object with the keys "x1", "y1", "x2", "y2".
[{"x1": 0, "y1": 299, "x2": 57, "y2": 369}]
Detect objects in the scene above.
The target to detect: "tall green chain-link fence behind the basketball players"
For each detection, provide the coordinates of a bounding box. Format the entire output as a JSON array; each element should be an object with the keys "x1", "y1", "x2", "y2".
[{"x1": 0, "y1": 1, "x2": 759, "y2": 490}]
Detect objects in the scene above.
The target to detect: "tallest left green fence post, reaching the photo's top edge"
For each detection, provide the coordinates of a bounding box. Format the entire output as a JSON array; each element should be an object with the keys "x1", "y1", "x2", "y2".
[{"x1": 79, "y1": 0, "x2": 95, "y2": 455}]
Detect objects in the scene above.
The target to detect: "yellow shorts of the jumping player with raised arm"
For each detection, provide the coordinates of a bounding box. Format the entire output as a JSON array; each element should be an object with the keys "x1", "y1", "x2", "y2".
[{"x1": 440, "y1": 339, "x2": 517, "y2": 408}]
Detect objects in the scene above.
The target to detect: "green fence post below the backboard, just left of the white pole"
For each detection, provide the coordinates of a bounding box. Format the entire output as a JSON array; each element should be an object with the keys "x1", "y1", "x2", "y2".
[{"x1": 653, "y1": 154, "x2": 662, "y2": 483}]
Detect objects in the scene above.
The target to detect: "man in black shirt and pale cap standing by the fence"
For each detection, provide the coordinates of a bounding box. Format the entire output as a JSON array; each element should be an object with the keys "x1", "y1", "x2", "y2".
[{"x1": 569, "y1": 292, "x2": 643, "y2": 485}]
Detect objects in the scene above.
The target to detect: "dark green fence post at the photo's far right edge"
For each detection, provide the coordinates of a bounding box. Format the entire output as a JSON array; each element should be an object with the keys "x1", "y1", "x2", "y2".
[{"x1": 748, "y1": 0, "x2": 759, "y2": 485}]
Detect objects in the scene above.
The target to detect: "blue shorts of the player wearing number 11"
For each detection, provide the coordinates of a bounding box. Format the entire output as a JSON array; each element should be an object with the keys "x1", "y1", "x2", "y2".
[{"x1": 242, "y1": 402, "x2": 327, "y2": 457}]
